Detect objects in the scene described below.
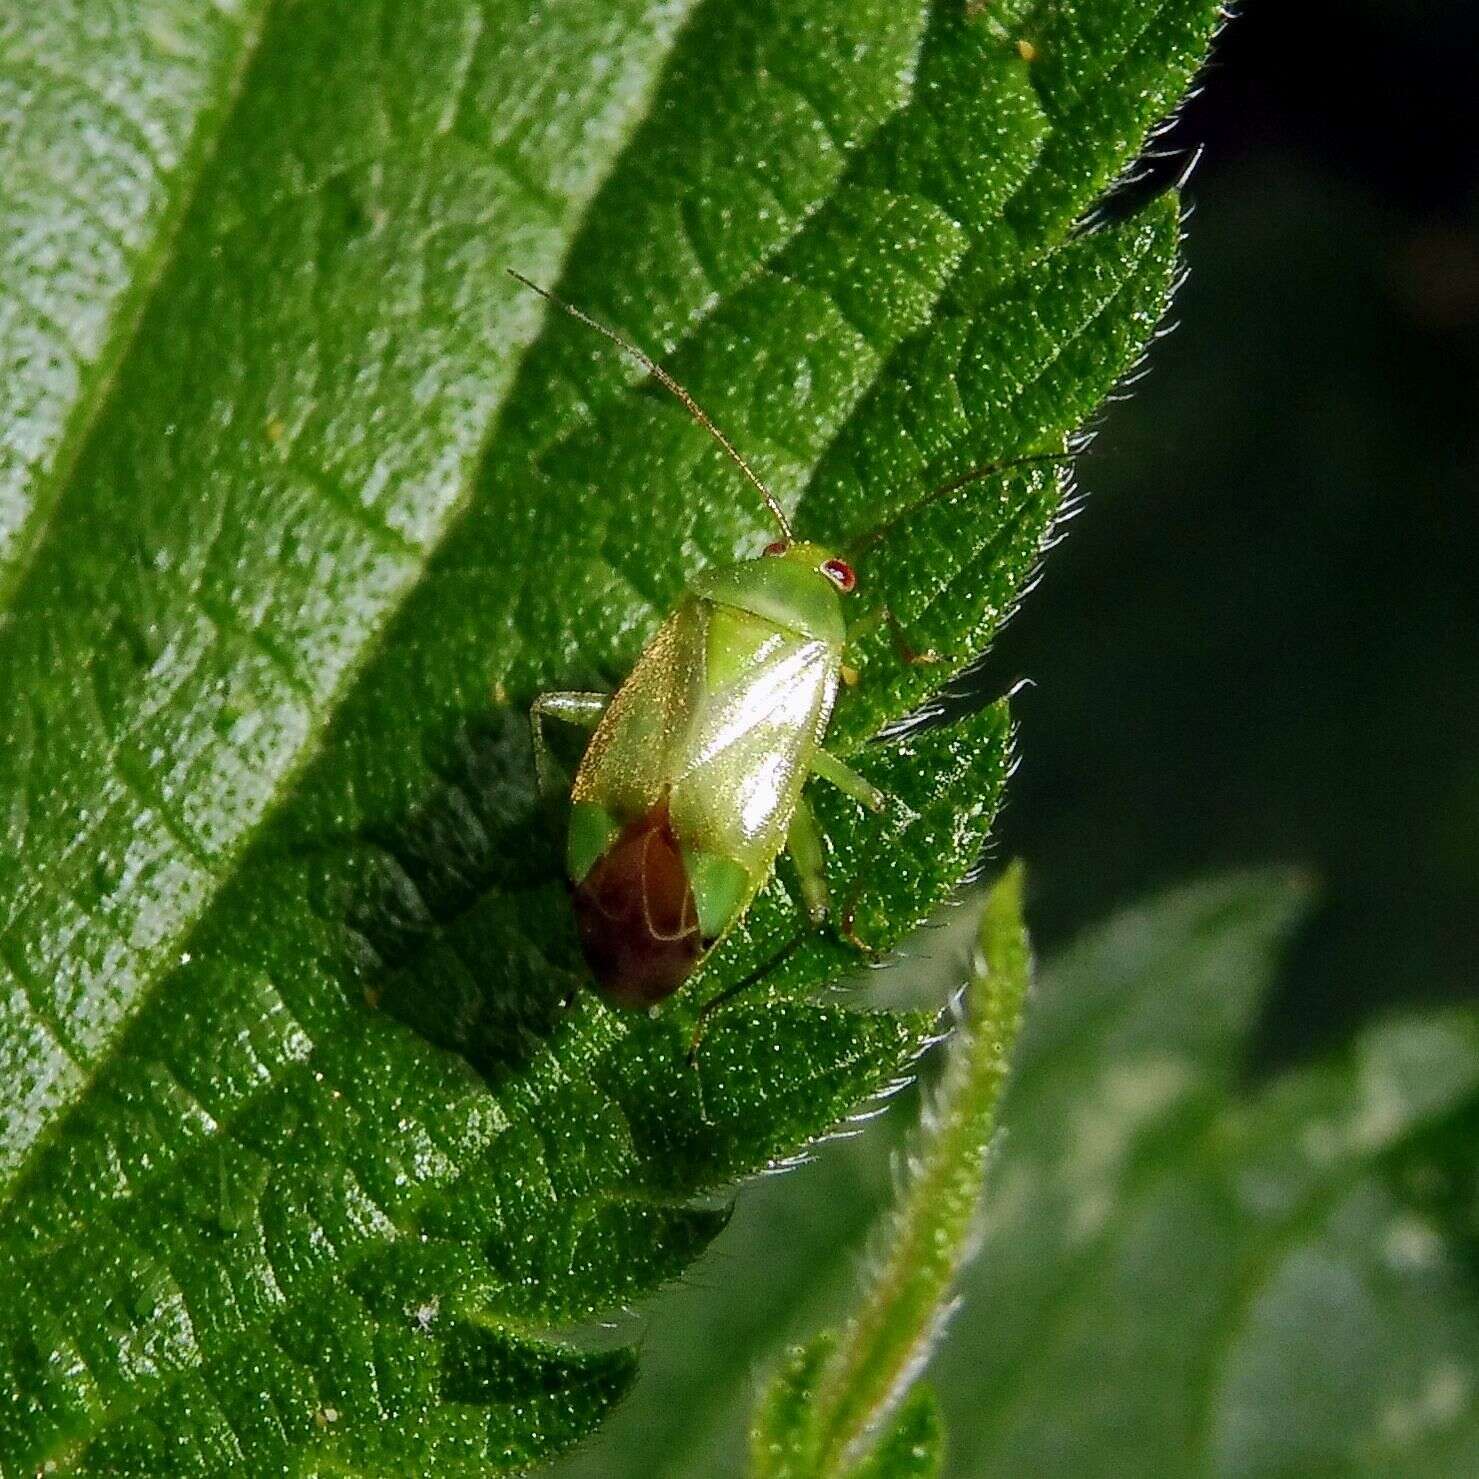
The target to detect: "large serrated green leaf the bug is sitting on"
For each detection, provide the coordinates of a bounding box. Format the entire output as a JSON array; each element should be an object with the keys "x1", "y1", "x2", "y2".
[{"x1": 0, "y1": 0, "x2": 1214, "y2": 1475}]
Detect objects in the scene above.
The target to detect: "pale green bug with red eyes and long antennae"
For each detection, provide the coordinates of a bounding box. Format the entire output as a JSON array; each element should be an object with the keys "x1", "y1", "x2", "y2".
[{"x1": 510, "y1": 269, "x2": 1058, "y2": 1044}]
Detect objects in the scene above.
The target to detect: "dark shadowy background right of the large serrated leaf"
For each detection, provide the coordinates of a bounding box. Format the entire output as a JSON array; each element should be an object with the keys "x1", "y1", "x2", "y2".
[{"x1": 982, "y1": 0, "x2": 1479, "y2": 1060}]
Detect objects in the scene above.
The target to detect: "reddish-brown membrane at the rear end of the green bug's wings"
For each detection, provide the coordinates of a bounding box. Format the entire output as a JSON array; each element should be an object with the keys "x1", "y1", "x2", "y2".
[{"x1": 575, "y1": 796, "x2": 704, "y2": 1007}]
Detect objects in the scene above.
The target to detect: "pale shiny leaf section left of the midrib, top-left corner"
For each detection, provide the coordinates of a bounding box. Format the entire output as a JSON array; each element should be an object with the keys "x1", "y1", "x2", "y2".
[{"x1": 0, "y1": 0, "x2": 265, "y2": 611}]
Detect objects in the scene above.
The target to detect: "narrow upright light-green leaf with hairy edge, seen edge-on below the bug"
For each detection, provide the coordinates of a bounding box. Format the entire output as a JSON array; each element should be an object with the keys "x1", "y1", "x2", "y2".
[{"x1": 751, "y1": 867, "x2": 1031, "y2": 1479}]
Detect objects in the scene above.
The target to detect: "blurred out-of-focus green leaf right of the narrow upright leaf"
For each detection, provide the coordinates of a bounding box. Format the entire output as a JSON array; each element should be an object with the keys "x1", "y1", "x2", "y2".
[{"x1": 942, "y1": 879, "x2": 1479, "y2": 1475}]
